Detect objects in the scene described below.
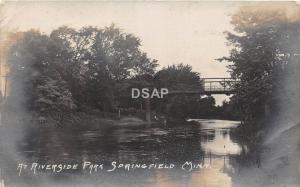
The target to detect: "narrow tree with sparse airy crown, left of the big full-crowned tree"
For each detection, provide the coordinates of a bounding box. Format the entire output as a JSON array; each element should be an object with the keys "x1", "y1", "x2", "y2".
[{"x1": 50, "y1": 26, "x2": 98, "y2": 105}]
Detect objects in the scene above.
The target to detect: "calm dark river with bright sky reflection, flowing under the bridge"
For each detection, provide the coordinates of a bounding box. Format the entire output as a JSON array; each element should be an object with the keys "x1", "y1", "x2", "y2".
[{"x1": 1, "y1": 119, "x2": 251, "y2": 187}]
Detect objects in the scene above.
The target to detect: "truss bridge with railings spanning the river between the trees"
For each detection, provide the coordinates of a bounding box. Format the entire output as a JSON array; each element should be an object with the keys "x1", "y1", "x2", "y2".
[{"x1": 168, "y1": 78, "x2": 240, "y2": 96}]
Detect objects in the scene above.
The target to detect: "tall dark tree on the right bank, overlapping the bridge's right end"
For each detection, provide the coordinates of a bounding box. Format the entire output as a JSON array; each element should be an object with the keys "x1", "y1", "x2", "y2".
[{"x1": 220, "y1": 6, "x2": 300, "y2": 131}]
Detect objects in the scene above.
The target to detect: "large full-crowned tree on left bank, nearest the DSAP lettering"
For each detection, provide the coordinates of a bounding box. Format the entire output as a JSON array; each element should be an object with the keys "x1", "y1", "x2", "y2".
[{"x1": 81, "y1": 25, "x2": 158, "y2": 110}]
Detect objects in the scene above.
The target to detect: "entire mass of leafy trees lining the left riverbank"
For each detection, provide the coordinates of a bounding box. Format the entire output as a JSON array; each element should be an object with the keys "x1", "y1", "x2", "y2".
[{"x1": 9, "y1": 25, "x2": 157, "y2": 117}]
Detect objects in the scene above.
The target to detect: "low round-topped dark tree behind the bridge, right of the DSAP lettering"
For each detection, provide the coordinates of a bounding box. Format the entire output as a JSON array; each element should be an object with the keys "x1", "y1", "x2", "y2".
[{"x1": 154, "y1": 64, "x2": 203, "y2": 119}]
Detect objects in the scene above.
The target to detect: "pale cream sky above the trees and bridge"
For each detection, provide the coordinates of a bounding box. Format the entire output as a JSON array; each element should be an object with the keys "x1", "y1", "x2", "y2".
[{"x1": 2, "y1": 1, "x2": 238, "y2": 104}]
